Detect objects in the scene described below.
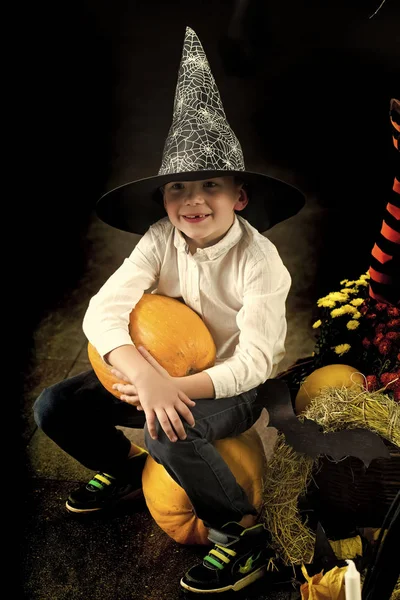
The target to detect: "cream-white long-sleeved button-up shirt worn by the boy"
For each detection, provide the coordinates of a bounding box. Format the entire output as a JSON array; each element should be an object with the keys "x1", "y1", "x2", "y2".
[{"x1": 83, "y1": 216, "x2": 291, "y2": 398}]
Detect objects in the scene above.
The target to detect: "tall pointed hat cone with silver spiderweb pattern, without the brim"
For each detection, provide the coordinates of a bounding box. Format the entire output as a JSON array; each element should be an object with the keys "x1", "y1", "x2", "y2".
[{"x1": 158, "y1": 27, "x2": 245, "y2": 175}]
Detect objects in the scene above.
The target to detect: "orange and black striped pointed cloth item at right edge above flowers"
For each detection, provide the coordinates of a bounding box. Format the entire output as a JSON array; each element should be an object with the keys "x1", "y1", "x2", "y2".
[{"x1": 369, "y1": 98, "x2": 400, "y2": 304}]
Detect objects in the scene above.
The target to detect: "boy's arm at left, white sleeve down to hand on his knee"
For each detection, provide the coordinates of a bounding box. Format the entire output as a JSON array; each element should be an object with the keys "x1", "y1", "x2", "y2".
[{"x1": 83, "y1": 226, "x2": 195, "y2": 441}]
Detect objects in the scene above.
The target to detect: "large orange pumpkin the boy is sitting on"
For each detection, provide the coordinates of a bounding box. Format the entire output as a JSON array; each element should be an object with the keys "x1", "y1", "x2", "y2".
[{"x1": 142, "y1": 427, "x2": 266, "y2": 544}]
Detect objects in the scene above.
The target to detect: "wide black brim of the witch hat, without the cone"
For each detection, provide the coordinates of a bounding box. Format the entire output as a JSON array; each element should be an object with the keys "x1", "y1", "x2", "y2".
[{"x1": 96, "y1": 170, "x2": 305, "y2": 235}]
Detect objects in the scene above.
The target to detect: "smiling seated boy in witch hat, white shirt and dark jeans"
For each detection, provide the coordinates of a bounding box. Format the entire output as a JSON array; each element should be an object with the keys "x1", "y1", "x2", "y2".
[{"x1": 35, "y1": 28, "x2": 304, "y2": 593}]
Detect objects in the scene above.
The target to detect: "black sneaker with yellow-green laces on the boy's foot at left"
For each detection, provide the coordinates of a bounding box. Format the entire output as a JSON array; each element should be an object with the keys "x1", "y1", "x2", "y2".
[{"x1": 65, "y1": 448, "x2": 148, "y2": 513}]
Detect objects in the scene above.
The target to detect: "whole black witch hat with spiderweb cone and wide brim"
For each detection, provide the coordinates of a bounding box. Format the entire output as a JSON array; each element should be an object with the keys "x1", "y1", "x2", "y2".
[{"x1": 96, "y1": 27, "x2": 304, "y2": 234}]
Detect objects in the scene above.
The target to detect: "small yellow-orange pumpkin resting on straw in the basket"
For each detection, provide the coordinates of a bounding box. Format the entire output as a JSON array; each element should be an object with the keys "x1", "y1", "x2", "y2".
[{"x1": 295, "y1": 364, "x2": 364, "y2": 415}]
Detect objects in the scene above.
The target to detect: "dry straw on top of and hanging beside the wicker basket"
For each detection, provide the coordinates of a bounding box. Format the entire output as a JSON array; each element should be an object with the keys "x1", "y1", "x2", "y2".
[{"x1": 261, "y1": 387, "x2": 400, "y2": 566}]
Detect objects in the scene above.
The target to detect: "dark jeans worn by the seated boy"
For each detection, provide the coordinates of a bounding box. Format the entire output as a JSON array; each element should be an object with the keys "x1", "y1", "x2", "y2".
[{"x1": 34, "y1": 370, "x2": 263, "y2": 527}]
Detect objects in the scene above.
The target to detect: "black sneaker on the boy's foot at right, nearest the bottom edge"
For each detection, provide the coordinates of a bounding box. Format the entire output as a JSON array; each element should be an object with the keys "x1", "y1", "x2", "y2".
[{"x1": 181, "y1": 522, "x2": 272, "y2": 594}]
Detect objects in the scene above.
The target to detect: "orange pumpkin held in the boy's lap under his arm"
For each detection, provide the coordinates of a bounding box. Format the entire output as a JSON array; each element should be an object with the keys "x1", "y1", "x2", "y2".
[{"x1": 88, "y1": 294, "x2": 216, "y2": 398}]
